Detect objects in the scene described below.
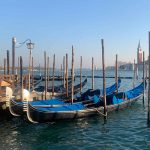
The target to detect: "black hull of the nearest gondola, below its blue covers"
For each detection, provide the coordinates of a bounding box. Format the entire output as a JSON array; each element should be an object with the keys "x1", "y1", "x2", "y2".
[{"x1": 28, "y1": 95, "x2": 141, "y2": 123}]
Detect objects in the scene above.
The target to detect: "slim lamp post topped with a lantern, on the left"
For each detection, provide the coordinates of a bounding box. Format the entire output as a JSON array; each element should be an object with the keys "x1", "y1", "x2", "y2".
[{"x1": 26, "y1": 39, "x2": 34, "y2": 91}]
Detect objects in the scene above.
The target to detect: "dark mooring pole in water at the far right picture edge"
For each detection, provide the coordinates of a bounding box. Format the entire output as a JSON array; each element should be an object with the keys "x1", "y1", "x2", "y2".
[{"x1": 147, "y1": 32, "x2": 150, "y2": 126}]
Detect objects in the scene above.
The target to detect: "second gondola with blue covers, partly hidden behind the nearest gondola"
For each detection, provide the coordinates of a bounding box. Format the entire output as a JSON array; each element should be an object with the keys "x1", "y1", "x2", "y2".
[{"x1": 9, "y1": 79, "x2": 121, "y2": 116}]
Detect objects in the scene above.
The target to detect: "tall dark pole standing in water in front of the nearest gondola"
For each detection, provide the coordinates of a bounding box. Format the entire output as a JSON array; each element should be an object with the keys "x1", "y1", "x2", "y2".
[{"x1": 101, "y1": 39, "x2": 107, "y2": 120}]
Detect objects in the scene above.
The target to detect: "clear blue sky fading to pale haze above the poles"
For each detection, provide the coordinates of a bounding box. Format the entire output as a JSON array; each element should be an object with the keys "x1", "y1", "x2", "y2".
[{"x1": 0, "y1": 0, "x2": 150, "y2": 68}]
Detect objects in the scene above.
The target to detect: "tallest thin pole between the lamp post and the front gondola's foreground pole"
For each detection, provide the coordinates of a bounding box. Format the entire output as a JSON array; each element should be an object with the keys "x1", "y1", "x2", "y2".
[{"x1": 71, "y1": 46, "x2": 74, "y2": 104}]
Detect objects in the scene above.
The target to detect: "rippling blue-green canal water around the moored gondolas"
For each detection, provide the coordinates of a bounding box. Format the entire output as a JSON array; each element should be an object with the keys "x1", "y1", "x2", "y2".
[{"x1": 0, "y1": 70, "x2": 150, "y2": 150}]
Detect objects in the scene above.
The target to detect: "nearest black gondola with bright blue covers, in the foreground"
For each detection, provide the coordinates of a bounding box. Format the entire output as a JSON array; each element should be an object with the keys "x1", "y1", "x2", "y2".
[{"x1": 27, "y1": 80, "x2": 144, "y2": 123}]
